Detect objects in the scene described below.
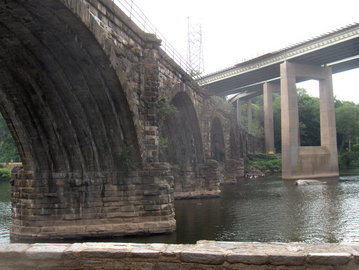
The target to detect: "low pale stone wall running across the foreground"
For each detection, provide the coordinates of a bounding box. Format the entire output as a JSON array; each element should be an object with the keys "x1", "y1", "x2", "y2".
[{"x1": 0, "y1": 241, "x2": 359, "y2": 270}]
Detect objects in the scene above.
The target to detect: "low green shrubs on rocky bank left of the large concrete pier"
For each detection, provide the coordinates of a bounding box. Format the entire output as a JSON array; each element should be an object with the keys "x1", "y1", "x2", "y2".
[{"x1": 247, "y1": 153, "x2": 282, "y2": 172}]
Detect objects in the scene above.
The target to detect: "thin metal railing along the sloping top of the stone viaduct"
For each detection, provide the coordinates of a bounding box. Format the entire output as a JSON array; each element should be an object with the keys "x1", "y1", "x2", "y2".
[{"x1": 112, "y1": 0, "x2": 200, "y2": 78}]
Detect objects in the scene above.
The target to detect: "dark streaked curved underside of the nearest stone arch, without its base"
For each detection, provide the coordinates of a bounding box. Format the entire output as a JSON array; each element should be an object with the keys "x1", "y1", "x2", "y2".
[{"x1": 0, "y1": 1, "x2": 142, "y2": 172}]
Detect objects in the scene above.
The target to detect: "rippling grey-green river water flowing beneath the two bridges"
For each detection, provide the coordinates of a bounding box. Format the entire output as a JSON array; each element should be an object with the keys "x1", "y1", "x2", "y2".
[{"x1": 0, "y1": 170, "x2": 359, "y2": 244}]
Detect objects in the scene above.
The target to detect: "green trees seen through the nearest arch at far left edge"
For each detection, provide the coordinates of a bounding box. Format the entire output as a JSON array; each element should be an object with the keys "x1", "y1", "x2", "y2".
[{"x1": 0, "y1": 114, "x2": 20, "y2": 163}]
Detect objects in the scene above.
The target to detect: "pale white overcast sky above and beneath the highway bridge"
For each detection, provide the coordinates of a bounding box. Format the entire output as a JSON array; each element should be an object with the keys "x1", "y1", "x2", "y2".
[{"x1": 119, "y1": 0, "x2": 359, "y2": 103}]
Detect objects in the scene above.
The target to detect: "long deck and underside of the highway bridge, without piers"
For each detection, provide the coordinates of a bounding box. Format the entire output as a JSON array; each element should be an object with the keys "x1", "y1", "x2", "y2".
[{"x1": 199, "y1": 24, "x2": 359, "y2": 97}]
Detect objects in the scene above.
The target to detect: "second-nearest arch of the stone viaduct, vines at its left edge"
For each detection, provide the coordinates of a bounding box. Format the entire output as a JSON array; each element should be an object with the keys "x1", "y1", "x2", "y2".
[{"x1": 160, "y1": 91, "x2": 206, "y2": 198}]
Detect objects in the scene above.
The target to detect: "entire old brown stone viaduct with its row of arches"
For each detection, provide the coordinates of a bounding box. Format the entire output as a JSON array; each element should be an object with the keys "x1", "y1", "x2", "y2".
[{"x1": 0, "y1": 0, "x2": 262, "y2": 240}]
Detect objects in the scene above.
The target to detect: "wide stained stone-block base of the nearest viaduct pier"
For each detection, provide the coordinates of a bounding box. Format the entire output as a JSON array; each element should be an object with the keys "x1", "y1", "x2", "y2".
[{"x1": 10, "y1": 163, "x2": 176, "y2": 240}]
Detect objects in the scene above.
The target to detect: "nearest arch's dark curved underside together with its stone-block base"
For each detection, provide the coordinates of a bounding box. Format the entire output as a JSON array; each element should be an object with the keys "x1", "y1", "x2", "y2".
[{"x1": 0, "y1": 0, "x2": 175, "y2": 240}]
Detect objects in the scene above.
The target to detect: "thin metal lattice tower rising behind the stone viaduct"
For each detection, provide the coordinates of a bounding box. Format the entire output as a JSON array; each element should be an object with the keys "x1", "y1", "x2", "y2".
[{"x1": 187, "y1": 17, "x2": 204, "y2": 78}]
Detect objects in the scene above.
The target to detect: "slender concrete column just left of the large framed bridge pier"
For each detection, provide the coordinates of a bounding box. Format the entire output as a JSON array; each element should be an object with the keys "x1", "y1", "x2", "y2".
[{"x1": 263, "y1": 83, "x2": 280, "y2": 153}]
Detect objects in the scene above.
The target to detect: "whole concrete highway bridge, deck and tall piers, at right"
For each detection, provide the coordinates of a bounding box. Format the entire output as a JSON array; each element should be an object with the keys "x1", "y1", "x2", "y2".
[{"x1": 199, "y1": 23, "x2": 359, "y2": 179}]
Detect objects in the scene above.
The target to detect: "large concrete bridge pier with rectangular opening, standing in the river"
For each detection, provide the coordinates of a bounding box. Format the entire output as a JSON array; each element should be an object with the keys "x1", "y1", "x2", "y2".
[{"x1": 280, "y1": 62, "x2": 339, "y2": 179}]
